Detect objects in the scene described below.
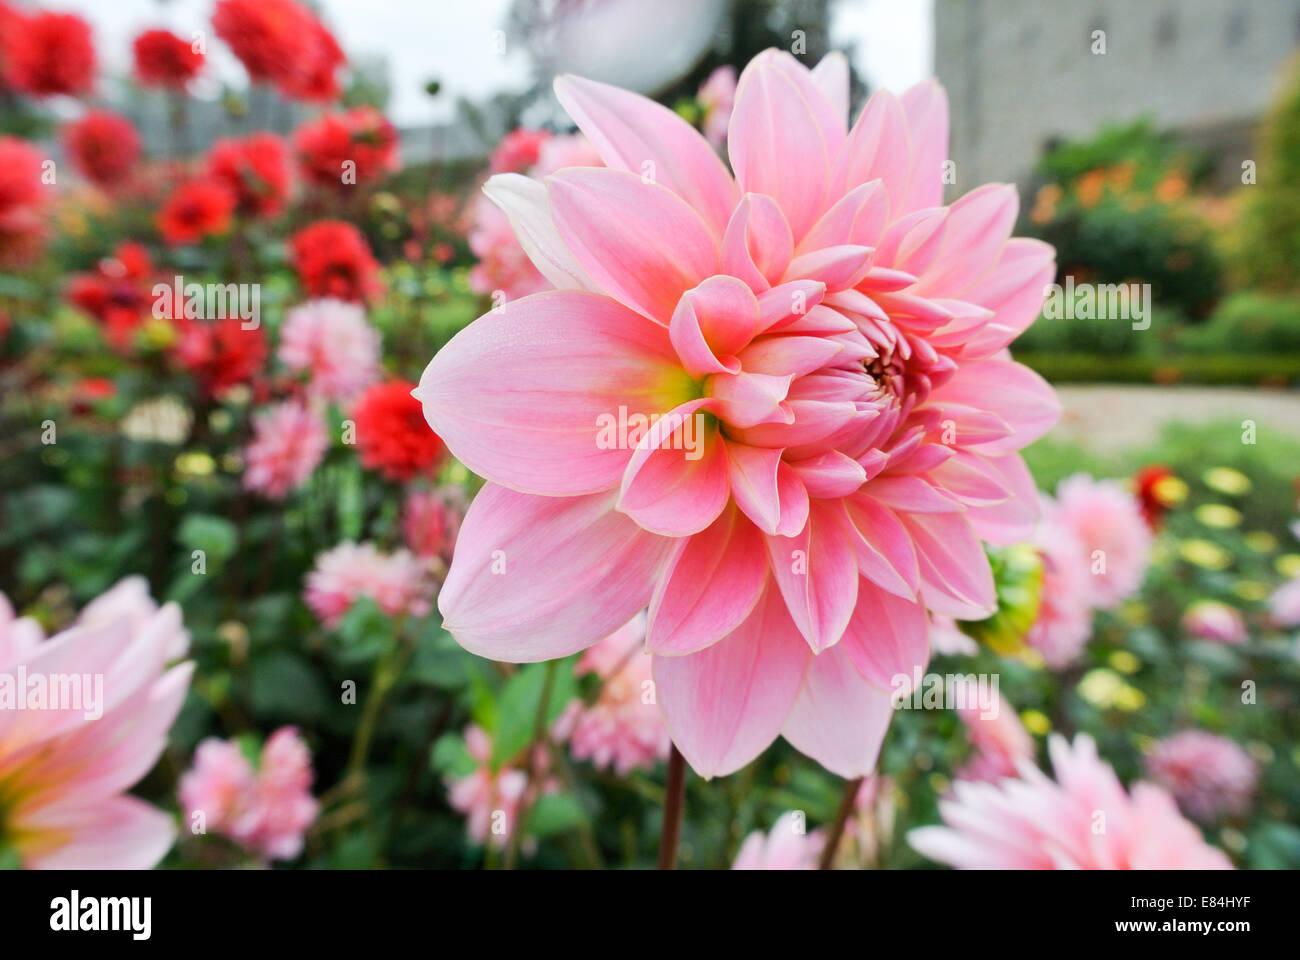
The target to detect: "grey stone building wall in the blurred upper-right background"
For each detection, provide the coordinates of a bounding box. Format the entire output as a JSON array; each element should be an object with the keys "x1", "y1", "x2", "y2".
[{"x1": 935, "y1": 0, "x2": 1300, "y2": 193}]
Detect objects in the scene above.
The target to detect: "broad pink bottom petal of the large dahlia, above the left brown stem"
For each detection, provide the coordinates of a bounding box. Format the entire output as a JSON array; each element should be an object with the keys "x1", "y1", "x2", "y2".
[{"x1": 653, "y1": 589, "x2": 809, "y2": 778}]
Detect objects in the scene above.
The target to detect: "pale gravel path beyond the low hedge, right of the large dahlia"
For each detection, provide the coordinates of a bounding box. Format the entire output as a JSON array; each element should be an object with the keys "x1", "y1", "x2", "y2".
[{"x1": 1053, "y1": 385, "x2": 1300, "y2": 451}]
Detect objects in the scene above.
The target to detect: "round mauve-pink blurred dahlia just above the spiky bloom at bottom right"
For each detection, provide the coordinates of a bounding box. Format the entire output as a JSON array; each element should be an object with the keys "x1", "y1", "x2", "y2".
[{"x1": 1147, "y1": 730, "x2": 1257, "y2": 822}]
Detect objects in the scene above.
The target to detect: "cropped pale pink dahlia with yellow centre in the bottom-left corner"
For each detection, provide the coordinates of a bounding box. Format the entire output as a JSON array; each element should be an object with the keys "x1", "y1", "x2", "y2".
[{"x1": 0, "y1": 584, "x2": 194, "y2": 870}]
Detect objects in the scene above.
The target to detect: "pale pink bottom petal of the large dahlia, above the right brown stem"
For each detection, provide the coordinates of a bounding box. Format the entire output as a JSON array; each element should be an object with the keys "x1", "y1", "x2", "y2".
[{"x1": 781, "y1": 644, "x2": 893, "y2": 779}]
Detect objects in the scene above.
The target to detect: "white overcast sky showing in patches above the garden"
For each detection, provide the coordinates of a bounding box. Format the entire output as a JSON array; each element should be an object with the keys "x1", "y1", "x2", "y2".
[{"x1": 48, "y1": 0, "x2": 933, "y2": 126}]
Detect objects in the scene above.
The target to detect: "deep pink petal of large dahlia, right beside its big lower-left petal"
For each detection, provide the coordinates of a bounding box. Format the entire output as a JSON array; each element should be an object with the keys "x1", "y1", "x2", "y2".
[{"x1": 646, "y1": 506, "x2": 768, "y2": 656}]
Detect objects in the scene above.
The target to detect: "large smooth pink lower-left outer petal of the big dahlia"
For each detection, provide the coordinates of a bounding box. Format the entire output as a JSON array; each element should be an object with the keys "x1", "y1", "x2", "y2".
[{"x1": 438, "y1": 484, "x2": 672, "y2": 663}]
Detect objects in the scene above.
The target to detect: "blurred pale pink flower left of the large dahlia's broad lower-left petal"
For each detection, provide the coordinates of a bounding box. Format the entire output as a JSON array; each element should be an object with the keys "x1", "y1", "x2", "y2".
[{"x1": 303, "y1": 542, "x2": 433, "y2": 627}]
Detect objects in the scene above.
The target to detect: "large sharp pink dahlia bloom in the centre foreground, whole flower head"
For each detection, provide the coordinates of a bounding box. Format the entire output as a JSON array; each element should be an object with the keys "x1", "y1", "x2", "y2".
[{"x1": 415, "y1": 51, "x2": 1058, "y2": 777}]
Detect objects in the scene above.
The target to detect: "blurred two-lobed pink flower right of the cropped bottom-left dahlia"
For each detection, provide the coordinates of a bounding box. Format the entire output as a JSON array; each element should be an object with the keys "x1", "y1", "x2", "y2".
[{"x1": 181, "y1": 727, "x2": 319, "y2": 860}]
